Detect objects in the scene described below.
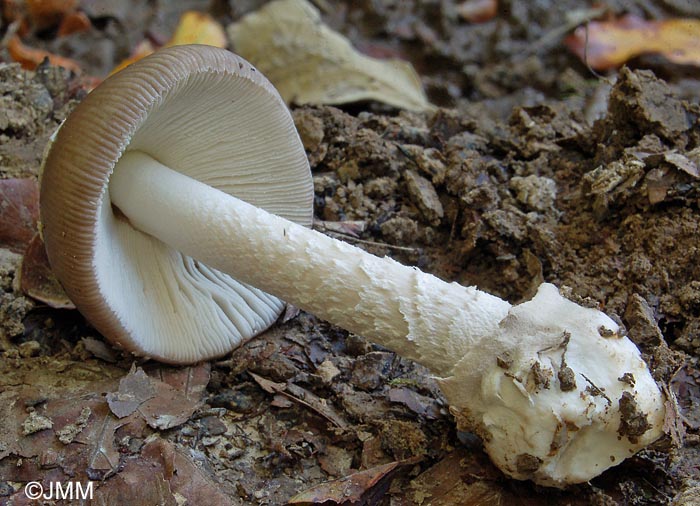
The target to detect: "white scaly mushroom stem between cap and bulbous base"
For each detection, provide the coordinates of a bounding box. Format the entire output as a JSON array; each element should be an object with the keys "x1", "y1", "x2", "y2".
[{"x1": 110, "y1": 152, "x2": 511, "y2": 376}]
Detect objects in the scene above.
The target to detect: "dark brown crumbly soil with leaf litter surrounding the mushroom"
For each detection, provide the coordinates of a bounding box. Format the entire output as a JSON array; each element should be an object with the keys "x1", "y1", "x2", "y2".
[{"x1": 0, "y1": 0, "x2": 700, "y2": 505}]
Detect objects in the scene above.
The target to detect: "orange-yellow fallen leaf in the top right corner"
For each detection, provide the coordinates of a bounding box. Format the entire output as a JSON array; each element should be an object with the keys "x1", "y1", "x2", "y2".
[{"x1": 565, "y1": 15, "x2": 700, "y2": 70}]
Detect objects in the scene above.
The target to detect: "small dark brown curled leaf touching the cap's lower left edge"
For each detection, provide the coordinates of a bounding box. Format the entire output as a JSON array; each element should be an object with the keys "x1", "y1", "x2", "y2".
[{"x1": 20, "y1": 233, "x2": 75, "y2": 309}]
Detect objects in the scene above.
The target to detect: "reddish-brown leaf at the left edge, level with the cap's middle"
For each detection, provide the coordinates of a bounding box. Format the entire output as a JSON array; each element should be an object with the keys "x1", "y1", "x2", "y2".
[{"x1": 0, "y1": 178, "x2": 39, "y2": 253}]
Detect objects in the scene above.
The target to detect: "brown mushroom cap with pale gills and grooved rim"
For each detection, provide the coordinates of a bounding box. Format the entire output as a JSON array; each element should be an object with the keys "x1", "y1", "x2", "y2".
[{"x1": 40, "y1": 45, "x2": 313, "y2": 363}]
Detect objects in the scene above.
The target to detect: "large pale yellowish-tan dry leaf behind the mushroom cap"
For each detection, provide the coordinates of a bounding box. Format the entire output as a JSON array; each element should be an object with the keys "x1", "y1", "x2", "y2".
[{"x1": 229, "y1": 0, "x2": 431, "y2": 111}]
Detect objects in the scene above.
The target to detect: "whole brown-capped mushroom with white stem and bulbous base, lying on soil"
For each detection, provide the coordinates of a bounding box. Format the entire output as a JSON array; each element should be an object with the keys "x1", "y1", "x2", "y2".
[{"x1": 41, "y1": 46, "x2": 664, "y2": 487}]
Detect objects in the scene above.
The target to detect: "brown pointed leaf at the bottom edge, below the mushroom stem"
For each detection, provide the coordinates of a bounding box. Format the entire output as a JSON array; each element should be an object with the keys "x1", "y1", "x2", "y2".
[{"x1": 287, "y1": 457, "x2": 422, "y2": 506}]
